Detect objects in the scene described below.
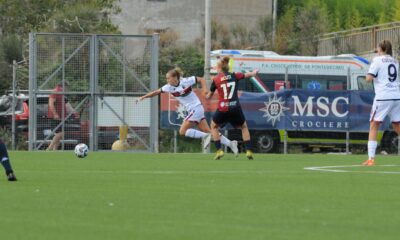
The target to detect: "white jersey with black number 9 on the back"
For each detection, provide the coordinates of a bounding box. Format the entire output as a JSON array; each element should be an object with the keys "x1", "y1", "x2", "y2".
[{"x1": 368, "y1": 55, "x2": 400, "y2": 101}]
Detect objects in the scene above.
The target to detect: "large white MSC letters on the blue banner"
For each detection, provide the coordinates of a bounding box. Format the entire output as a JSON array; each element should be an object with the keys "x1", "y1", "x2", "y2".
[{"x1": 292, "y1": 96, "x2": 349, "y2": 118}]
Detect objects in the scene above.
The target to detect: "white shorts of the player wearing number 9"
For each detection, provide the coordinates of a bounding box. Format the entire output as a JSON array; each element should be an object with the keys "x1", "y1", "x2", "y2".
[{"x1": 369, "y1": 100, "x2": 400, "y2": 123}]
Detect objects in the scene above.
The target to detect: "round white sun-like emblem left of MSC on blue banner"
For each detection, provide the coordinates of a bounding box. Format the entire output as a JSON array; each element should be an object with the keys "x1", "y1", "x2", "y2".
[{"x1": 259, "y1": 94, "x2": 289, "y2": 126}]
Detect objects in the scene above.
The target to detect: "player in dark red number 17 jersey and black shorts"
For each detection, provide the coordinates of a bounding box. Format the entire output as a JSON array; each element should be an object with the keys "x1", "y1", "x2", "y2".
[{"x1": 207, "y1": 56, "x2": 258, "y2": 160}]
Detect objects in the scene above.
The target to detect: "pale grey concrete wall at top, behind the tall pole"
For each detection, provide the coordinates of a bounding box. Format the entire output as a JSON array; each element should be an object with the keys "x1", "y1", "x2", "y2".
[{"x1": 112, "y1": 0, "x2": 272, "y2": 42}]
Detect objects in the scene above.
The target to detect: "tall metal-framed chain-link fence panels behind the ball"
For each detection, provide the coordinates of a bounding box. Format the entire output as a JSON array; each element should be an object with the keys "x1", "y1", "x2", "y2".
[{"x1": 29, "y1": 33, "x2": 158, "y2": 152}]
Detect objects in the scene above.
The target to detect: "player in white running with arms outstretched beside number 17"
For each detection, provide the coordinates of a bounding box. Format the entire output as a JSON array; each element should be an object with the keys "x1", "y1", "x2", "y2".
[{"x1": 136, "y1": 68, "x2": 238, "y2": 156}]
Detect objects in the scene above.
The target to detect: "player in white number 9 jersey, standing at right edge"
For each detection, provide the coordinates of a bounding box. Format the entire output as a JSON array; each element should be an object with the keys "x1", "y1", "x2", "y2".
[{"x1": 364, "y1": 40, "x2": 400, "y2": 166}]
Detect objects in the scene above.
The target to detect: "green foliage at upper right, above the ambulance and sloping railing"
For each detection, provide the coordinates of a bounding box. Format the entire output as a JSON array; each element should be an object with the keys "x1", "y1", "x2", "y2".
[{"x1": 275, "y1": 0, "x2": 400, "y2": 55}]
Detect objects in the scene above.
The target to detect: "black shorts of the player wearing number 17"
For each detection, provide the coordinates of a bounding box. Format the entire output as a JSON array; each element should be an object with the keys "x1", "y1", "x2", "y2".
[{"x1": 213, "y1": 107, "x2": 246, "y2": 128}]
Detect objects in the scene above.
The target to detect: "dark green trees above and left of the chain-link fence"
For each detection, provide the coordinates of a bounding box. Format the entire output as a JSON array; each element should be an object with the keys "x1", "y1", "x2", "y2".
[{"x1": 0, "y1": 0, "x2": 120, "y2": 92}]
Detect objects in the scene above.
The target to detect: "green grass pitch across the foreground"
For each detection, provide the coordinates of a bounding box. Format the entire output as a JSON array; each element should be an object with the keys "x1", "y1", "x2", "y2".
[{"x1": 0, "y1": 152, "x2": 400, "y2": 240}]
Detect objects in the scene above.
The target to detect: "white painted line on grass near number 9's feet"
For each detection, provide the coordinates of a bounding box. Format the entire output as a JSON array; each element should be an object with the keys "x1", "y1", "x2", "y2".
[{"x1": 304, "y1": 164, "x2": 400, "y2": 174}]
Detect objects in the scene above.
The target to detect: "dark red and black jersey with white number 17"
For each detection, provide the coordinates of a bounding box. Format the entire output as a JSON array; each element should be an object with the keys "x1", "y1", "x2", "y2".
[{"x1": 210, "y1": 72, "x2": 244, "y2": 112}]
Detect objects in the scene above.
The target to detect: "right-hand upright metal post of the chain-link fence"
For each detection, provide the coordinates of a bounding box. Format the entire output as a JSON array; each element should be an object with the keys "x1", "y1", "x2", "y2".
[{"x1": 150, "y1": 34, "x2": 160, "y2": 153}]
